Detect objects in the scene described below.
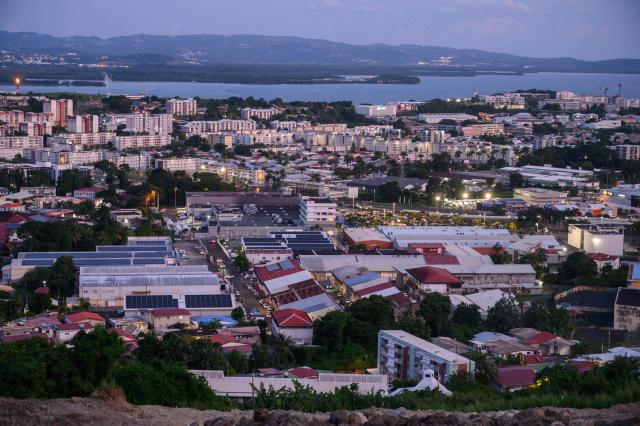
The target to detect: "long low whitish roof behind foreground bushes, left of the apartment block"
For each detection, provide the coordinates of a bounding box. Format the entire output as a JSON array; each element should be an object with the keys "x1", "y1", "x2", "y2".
[{"x1": 191, "y1": 370, "x2": 389, "y2": 398}]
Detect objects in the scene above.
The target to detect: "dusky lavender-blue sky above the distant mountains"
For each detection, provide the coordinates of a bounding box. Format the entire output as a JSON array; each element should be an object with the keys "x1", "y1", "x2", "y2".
[{"x1": 0, "y1": 0, "x2": 640, "y2": 60}]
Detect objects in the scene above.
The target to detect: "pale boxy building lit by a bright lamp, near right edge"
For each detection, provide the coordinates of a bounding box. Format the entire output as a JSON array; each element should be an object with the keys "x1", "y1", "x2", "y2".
[{"x1": 568, "y1": 224, "x2": 624, "y2": 256}]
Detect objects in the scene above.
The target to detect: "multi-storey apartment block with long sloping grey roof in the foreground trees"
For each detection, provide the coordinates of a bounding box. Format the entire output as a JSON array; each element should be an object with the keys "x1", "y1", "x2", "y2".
[{"x1": 378, "y1": 330, "x2": 475, "y2": 383}]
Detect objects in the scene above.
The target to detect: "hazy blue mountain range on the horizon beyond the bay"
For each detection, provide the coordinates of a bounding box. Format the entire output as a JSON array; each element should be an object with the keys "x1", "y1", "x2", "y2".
[{"x1": 0, "y1": 31, "x2": 640, "y2": 74}]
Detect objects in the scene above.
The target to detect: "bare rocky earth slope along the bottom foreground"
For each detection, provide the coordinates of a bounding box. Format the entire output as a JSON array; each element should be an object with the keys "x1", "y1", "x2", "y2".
[{"x1": 0, "y1": 390, "x2": 640, "y2": 426}]
